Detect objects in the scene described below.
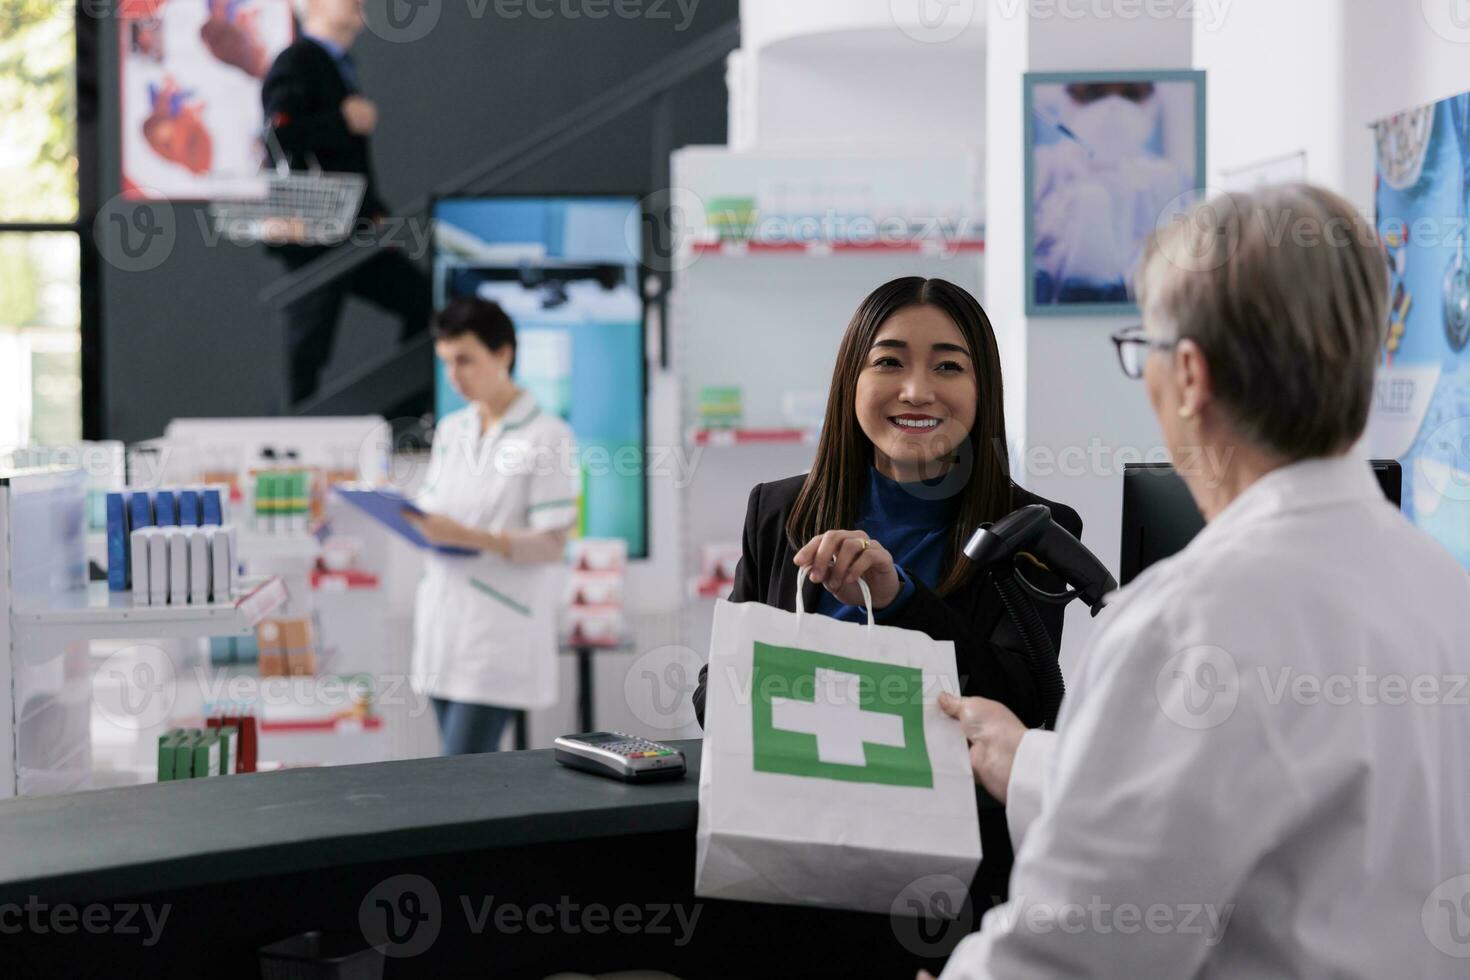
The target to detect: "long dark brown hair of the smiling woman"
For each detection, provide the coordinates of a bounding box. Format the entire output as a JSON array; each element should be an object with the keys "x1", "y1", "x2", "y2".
[{"x1": 786, "y1": 276, "x2": 1011, "y2": 595}]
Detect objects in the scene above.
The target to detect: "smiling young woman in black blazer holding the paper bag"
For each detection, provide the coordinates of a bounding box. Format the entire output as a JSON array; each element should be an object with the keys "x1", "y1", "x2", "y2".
[{"x1": 694, "y1": 278, "x2": 1082, "y2": 907}]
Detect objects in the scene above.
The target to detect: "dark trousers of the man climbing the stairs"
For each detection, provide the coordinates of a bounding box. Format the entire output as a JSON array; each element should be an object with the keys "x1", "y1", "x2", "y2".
[{"x1": 281, "y1": 248, "x2": 434, "y2": 410}]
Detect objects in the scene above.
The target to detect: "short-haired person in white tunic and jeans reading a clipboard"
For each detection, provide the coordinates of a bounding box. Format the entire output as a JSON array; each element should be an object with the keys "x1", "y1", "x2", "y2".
[{"x1": 403, "y1": 297, "x2": 578, "y2": 755}]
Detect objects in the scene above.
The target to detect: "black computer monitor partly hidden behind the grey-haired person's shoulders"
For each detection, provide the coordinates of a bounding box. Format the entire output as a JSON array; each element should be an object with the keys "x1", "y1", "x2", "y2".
[{"x1": 1119, "y1": 460, "x2": 1404, "y2": 585}]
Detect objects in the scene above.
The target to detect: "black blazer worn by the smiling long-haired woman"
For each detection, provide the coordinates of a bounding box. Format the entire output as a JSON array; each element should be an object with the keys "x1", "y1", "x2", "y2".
[{"x1": 694, "y1": 476, "x2": 1082, "y2": 727}]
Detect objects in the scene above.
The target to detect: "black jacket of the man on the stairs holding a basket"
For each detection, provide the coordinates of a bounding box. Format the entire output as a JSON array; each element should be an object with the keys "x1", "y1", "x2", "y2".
[{"x1": 260, "y1": 37, "x2": 388, "y2": 258}]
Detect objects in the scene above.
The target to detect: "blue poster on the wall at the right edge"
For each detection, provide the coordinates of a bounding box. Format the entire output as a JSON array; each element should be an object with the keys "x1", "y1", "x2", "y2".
[{"x1": 1369, "y1": 94, "x2": 1470, "y2": 569}]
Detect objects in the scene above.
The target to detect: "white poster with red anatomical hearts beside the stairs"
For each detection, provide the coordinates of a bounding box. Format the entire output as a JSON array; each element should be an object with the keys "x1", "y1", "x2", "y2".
[{"x1": 118, "y1": 0, "x2": 294, "y2": 200}]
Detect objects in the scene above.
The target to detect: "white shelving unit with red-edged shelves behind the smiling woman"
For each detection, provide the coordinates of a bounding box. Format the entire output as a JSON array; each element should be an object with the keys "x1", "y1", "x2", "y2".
[{"x1": 669, "y1": 147, "x2": 985, "y2": 655}]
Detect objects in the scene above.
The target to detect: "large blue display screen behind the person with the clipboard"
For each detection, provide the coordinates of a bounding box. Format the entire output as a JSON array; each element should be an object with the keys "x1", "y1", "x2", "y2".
[{"x1": 434, "y1": 197, "x2": 648, "y2": 558}]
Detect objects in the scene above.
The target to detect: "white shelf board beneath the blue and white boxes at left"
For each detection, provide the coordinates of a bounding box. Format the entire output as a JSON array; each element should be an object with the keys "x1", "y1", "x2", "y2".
[{"x1": 12, "y1": 576, "x2": 287, "y2": 649}]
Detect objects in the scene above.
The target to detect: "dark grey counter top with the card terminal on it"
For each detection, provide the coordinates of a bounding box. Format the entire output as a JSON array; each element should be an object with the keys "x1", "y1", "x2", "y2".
[{"x1": 0, "y1": 739, "x2": 701, "y2": 902}]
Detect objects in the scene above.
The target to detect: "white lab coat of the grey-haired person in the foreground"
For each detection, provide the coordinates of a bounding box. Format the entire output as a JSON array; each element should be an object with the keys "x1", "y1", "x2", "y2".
[{"x1": 944, "y1": 458, "x2": 1470, "y2": 980}]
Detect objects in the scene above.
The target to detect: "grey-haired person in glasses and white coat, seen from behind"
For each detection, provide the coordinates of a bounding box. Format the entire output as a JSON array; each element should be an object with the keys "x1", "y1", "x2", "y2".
[{"x1": 944, "y1": 185, "x2": 1470, "y2": 980}]
